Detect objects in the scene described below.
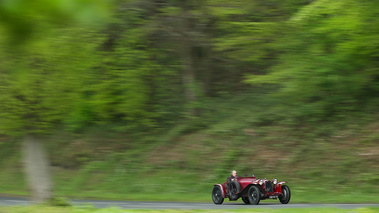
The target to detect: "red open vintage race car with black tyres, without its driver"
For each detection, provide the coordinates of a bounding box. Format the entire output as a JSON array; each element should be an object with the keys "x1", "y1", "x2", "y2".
[{"x1": 212, "y1": 175, "x2": 291, "y2": 205}]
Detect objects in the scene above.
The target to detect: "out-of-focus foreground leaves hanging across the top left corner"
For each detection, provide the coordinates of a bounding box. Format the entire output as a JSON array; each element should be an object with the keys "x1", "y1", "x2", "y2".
[{"x1": 0, "y1": 0, "x2": 110, "y2": 46}]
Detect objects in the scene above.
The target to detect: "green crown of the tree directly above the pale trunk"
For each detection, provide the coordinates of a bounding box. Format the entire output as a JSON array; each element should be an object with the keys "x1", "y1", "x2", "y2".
[{"x1": 0, "y1": 29, "x2": 101, "y2": 134}]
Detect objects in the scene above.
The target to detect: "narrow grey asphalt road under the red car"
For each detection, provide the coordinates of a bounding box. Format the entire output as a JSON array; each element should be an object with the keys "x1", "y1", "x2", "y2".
[{"x1": 0, "y1": 197, "x2": 379, "y2": 209}]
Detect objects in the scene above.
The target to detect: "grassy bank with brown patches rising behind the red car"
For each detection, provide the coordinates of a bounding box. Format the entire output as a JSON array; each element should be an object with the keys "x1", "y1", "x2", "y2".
[{"x1": 0, "y1": 93, "x2": 379, "y2": 203}]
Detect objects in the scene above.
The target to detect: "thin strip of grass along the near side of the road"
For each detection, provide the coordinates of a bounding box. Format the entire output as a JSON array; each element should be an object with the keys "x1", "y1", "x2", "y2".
[{"x1": 0, "y1": 206, "x2": 379, "y2": 213}]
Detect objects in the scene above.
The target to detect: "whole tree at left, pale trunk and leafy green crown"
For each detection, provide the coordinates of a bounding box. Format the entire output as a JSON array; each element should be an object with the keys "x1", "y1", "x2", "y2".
[{"x1": 0, "y1": 0, "x2": 110, "y2": 202}]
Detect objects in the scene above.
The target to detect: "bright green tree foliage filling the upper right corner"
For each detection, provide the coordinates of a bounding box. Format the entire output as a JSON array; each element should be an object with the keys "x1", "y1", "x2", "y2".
[{"x1": 247, "y1": 1, "x2": 379, "y2": 122}]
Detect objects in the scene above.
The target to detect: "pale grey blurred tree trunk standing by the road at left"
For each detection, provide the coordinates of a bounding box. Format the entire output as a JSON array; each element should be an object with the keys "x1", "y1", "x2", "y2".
[{"x1": 23, "y1": 135, "x2": 52, "y2": 202}]
